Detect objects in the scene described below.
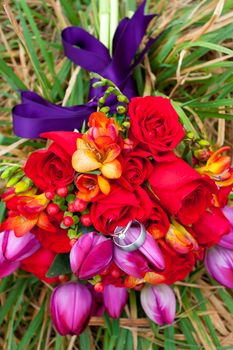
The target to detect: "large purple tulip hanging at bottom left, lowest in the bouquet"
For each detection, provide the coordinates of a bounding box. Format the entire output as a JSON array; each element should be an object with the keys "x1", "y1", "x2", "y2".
[{"x1": 50, "y1": 282, "x2": 92, "y2": 335}]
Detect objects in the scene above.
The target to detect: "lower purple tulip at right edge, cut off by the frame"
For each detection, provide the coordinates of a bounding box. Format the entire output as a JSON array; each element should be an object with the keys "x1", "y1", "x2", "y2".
[{"x1": 205, "y1": 246, "x2": 233, "y2": 289}]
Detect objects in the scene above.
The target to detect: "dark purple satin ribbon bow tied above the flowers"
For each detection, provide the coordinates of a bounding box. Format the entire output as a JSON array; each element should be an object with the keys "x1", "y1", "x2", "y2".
[{"x1": 12, "y1": 0, "x2": 156, "y2": 138}]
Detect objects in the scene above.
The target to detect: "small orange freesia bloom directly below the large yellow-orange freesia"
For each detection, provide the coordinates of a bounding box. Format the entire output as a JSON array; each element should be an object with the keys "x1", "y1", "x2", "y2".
[{"x1": 76, "y1": 174, "x2": 110, "y2": 202}]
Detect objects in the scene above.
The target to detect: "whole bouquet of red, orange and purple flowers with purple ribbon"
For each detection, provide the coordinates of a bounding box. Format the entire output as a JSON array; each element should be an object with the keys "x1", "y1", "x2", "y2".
[{"x1": 0, "y1": 2, "x2": 233, "y2": 335}]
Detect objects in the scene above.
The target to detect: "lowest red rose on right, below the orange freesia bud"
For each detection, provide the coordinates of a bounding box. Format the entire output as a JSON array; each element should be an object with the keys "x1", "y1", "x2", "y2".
[{"x1": 158, "y1": 240, "x2": 196, "y2": 284}]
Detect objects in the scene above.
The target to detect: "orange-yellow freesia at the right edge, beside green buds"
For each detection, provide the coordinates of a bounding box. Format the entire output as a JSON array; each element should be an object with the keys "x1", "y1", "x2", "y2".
[{"x1": 196, "y1": 146, "x2": 233, "y2": 187}]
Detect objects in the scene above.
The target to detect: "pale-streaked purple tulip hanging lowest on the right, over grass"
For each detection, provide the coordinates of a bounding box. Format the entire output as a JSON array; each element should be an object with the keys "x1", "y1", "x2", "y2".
[{"x1": 141, "y1": 284, "x2": 176, "y2": 326}]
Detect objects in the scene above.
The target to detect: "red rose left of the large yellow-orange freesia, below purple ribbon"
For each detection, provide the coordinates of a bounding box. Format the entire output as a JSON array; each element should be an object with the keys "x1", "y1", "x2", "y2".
[{"x1": 24, "y1": 132, "x2": 79, "y2": 191}]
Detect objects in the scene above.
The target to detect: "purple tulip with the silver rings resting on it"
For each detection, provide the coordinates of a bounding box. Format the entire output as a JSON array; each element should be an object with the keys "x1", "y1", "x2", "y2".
[{"x1": 114, "y1": 227, "x2": 165, "y2": 278}]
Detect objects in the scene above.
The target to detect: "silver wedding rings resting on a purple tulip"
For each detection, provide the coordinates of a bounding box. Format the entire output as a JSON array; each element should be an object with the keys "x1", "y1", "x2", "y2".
[{"x1": 113, "y1": 220, "x2": 146, "y2": 252}]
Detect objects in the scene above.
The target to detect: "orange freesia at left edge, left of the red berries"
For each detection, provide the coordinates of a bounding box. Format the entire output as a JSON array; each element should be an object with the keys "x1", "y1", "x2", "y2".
[{"x1": 2, "y1": 193, "x2": 55, "y2": 237}]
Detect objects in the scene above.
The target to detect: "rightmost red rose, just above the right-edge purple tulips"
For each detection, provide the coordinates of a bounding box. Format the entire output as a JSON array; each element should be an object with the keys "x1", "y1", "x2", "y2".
[{"x1": 192, "y1": 207, "x2": 231, "y2": 247}]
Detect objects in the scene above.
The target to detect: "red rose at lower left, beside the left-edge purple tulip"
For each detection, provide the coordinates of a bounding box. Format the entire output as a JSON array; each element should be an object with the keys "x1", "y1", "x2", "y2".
[{"x1": 20, "y1": 248, "x2": 59, "y2": 283}]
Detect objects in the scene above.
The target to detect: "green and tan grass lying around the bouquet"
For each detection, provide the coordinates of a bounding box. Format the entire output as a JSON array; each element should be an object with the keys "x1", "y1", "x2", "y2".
[{"x1": 0, "y1": 0, "x2": 233, "y2": 350}]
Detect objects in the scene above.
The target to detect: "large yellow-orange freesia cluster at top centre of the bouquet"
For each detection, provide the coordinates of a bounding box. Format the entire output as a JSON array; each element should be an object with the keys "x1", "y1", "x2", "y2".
[{"x1": 72, "y1": 112, "x2": 122, "y2": 179}]
